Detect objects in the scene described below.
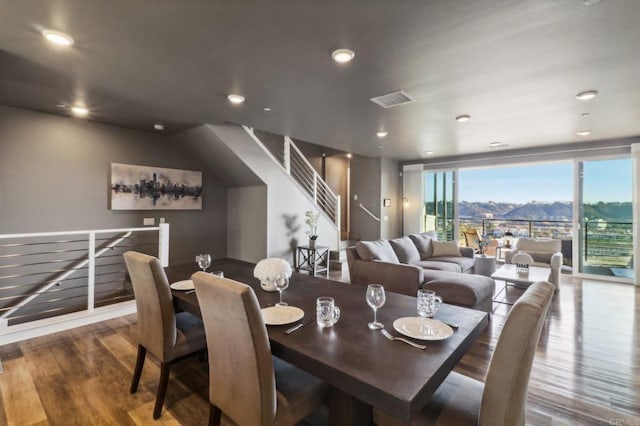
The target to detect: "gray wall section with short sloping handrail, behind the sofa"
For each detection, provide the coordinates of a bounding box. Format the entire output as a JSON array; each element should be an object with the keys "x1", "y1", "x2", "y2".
[{"x1": 350, "y1": 155, "x2": 382, "y2": 240}]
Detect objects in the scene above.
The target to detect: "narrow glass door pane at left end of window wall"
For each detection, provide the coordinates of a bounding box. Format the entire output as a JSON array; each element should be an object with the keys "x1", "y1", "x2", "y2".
[{"x1": 423, "y1": 170, "x2": 456, "y2": 241}]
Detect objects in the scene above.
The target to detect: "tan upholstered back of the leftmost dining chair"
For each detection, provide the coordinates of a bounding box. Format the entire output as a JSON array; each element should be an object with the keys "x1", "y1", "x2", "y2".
[{"x1": 123, "y1": 251, "x2": 176, "y2": 362}]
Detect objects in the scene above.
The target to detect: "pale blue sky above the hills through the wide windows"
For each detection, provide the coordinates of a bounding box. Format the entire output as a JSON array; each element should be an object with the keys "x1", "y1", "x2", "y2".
[{"x1": 458, "y1": 159, "x2": 632, "y2": 203}]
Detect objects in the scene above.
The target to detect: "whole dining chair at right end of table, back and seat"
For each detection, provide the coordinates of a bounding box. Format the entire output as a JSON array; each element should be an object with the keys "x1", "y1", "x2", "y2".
[{"x1": 374, "y1": 281, "x2": 554, "y2": 426}]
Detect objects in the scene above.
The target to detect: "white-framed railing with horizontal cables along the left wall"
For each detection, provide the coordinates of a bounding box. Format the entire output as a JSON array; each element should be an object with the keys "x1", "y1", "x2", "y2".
[{"x1": 0, "y1": 224, "x2": 168, "y2": 328}]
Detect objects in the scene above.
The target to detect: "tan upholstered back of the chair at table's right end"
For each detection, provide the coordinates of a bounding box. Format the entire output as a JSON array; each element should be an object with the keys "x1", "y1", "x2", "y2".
[{"x1": 479, "y1": 281, "x2": 555, "y2": 426}]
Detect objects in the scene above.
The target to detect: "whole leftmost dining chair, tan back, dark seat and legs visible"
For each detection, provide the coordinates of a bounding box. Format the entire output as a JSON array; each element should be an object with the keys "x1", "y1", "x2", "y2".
[{"x1": 124, "y1": 251, "x2": 206, "y2": 419}]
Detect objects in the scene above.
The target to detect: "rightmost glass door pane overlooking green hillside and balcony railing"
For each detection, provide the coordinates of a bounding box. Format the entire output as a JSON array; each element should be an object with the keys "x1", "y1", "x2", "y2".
[{"x1": 577, "y1": 158, "x2": 634, "y2": 280}]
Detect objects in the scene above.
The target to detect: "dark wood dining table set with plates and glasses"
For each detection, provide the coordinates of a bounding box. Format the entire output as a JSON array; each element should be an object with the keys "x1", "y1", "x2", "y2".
[{"x1": 166, "y1": 259, "x2": 488, "y2": 425}]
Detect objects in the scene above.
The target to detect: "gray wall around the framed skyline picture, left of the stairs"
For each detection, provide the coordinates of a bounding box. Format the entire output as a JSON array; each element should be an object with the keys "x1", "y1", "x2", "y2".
[{"x1": 0, "y1": 106, "x2": 227, "y2": 263}]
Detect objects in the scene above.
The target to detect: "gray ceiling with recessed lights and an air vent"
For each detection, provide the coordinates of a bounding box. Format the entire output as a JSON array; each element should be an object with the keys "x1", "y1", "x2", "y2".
[{"x1": 0, "y1": 0, "x2": 640, "y2": 160}]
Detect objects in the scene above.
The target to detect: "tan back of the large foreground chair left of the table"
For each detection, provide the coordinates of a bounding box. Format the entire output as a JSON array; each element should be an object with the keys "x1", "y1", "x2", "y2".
[{"x1": 192, "y1": 272, "x2": 277, "y2": 425}]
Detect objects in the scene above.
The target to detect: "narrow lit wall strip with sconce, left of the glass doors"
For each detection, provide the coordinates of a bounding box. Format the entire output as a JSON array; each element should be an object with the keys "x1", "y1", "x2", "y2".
[{"x1": 380, "y1": 158, "x2": 402, "y2": 239}]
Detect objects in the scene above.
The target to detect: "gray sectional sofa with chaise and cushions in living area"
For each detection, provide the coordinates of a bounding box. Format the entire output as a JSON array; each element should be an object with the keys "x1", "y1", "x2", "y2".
[{"x1": 347, "y1": 233, "x2": 495, "y2": 313}]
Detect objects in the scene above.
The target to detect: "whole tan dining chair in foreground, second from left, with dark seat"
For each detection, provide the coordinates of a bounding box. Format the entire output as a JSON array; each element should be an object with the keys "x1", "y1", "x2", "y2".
[{"x1": 192, "y1": 272, "x2": 327, "y2": 425}]
